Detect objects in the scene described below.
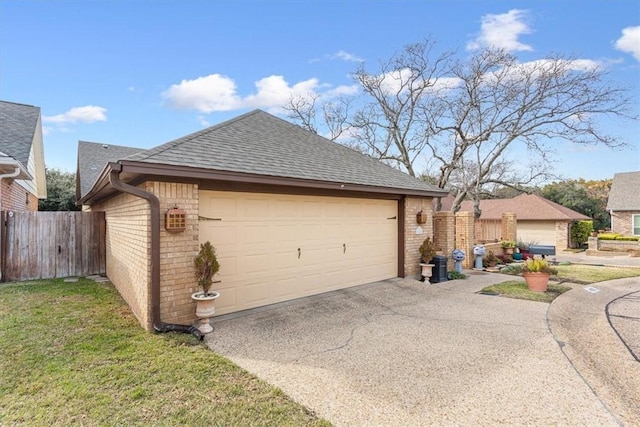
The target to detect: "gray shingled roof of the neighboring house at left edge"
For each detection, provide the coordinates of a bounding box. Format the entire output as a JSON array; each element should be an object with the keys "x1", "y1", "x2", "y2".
[{"x1": 0, "y1": 101, "x2": 40, "y2": 166}]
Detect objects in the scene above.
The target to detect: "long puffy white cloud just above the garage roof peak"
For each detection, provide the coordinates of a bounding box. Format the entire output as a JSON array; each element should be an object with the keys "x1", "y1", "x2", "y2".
[{"x1": 162, "y1": 74, "x2": 357, "y2": 114}]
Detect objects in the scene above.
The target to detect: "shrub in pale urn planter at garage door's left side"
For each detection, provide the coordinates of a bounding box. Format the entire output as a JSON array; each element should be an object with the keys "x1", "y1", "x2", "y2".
[{"x1": 191, "y1": 242, "x2": 220, "y2": 334}]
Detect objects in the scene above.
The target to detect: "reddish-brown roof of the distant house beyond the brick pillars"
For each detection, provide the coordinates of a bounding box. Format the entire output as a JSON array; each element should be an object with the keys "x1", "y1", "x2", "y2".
[{"x1": 460, "y1": 194, "x2": 591, "y2": 221}]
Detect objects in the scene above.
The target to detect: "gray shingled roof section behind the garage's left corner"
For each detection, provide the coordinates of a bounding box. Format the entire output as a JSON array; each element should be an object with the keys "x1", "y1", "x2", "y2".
[{"x1": 77, "y1": 141, "x2": 145, "y2": 196}]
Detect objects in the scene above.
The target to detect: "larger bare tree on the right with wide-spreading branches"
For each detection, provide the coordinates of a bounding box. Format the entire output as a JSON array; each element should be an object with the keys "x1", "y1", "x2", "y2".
[{"x1": 424, "y1": 49, "x2": 636, "y2": 215}]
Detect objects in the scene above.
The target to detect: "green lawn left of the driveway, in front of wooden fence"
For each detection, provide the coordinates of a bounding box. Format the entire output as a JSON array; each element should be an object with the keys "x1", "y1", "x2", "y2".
[{"x1": 0, "y1": 279, "x2": 330, "y2": 426}]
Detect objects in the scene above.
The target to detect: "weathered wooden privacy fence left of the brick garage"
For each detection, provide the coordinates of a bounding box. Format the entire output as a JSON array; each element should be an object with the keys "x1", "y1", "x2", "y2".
[{"x1": 0, "y1": 211, "x2": 106, "y2": 282}]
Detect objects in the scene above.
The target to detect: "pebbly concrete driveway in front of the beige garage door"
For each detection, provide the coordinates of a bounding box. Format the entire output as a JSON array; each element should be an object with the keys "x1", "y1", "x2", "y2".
[{"x1": 206, "y1": 272, "x2": 640, "y2": 426}]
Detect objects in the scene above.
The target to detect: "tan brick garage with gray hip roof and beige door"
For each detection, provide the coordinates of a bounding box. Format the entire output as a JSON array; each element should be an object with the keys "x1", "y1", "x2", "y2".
[{"x1": 78, "y1": 110, "x2": 444, "y2": 330}]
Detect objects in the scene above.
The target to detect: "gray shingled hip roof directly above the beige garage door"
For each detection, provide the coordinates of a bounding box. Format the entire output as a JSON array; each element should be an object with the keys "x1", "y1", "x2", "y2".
[{"x1": 126, "y1": 110, "x2": 442, "y2": 192}]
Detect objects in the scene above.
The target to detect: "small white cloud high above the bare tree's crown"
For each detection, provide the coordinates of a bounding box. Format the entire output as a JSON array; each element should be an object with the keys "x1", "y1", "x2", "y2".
[{"x1": 467, "y1": 9, "x2": 533, "y2": 52}]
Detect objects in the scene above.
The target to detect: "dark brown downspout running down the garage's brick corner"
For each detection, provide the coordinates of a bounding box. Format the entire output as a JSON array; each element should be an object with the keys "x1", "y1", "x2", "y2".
[{"x1": 109, "y1": 164, "x2": 204, "y2": 340}]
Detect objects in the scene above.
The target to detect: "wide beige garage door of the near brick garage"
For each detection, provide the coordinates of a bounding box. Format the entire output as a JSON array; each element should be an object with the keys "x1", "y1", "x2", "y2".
[{"x1": 200, "y1": 191, "x2": 398, "y2": 314}]
